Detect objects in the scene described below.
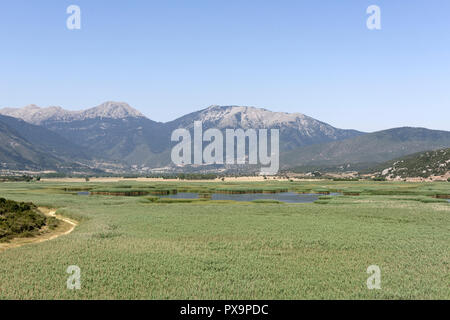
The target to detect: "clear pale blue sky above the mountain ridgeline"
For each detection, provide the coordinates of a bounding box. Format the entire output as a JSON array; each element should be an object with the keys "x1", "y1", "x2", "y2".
[{"x1": 0, "y1": 0, "x2": 450, "y2": 131}]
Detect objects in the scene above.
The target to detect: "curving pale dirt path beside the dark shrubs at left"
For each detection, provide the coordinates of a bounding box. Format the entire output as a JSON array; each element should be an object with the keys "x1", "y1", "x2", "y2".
[{"x1": 0, "y1": 208, "x2": 78, "y2": 252}]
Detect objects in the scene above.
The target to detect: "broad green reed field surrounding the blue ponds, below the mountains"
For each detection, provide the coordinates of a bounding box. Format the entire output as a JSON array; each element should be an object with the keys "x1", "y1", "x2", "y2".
[{"x1": 0, "y1": 181, "x2": 450, "y2": 299}]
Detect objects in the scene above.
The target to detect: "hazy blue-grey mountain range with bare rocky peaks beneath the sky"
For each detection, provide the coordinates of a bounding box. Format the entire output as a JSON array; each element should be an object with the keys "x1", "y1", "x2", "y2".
[{"x1": 0, "y1": 102, "x2": 450, "y2": 171}]
